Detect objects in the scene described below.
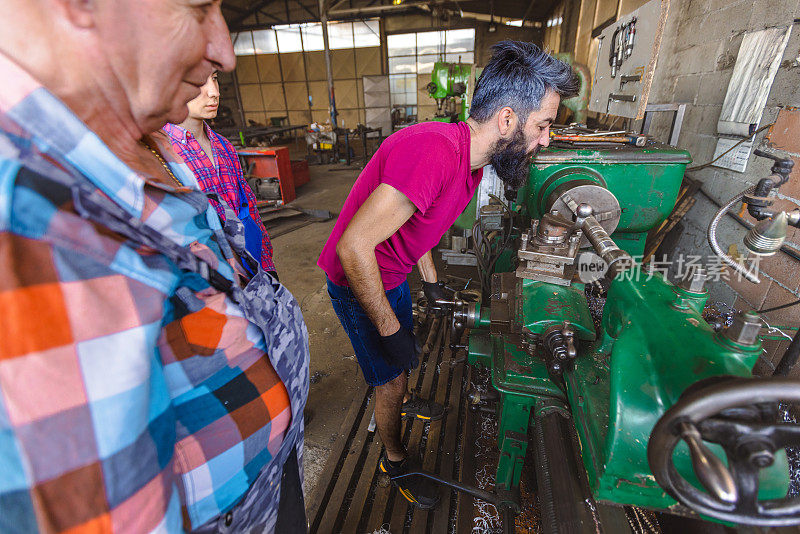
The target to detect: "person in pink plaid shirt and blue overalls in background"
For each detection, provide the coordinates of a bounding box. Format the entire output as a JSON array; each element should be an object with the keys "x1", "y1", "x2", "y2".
[{"x1": 164, "y1": 71, "x2": 278, "y2": 278}]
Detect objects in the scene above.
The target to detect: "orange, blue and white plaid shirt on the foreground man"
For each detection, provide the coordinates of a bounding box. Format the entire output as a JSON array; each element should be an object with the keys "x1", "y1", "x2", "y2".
[{"x1": 0, "y1": 54, "x2": 309, "y2": 533}]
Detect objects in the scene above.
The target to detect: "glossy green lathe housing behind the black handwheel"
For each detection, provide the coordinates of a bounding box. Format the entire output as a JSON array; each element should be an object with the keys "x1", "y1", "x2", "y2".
[{"x1": 569, "y1": 271, "x2": 789, "y2": 508}]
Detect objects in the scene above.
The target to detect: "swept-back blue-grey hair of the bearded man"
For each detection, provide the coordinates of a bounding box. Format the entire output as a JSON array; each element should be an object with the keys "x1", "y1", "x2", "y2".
[{"x1": 469, "y1": 41, "x2": 578, "y2": 124}]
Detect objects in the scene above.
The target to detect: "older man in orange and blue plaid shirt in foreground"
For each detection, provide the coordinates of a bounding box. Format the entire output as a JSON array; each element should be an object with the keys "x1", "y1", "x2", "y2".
[{"x1": 0, "y1": 0, "x2": 309, "y2": 533}]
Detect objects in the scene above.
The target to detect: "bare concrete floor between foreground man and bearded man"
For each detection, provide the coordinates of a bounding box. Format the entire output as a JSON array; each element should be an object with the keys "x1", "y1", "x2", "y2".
[{"x1": 272, "y1": 161, "x2": 363, "y2": 496}]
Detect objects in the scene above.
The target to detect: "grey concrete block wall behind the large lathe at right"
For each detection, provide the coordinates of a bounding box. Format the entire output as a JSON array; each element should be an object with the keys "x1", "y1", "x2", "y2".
[{"x1": 649, "y1": 0, "x2": 800, "y2": 376}]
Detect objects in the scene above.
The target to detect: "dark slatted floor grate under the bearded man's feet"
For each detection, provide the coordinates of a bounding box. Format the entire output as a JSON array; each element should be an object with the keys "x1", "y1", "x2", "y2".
[{"x1": 308, "y1": 318, "x2": 472, "y2": 534}]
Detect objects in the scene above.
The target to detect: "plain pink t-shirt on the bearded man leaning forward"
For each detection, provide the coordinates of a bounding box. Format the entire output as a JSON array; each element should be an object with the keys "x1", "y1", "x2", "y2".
[{"x1": 317, "y1": 122, "x2": 483, "y2": 291}]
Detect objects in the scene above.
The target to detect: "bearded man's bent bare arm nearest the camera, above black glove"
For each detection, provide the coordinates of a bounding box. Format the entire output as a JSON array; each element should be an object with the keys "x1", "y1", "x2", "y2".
[{"x1": 336, "y1": 184, "x2": 416, "y2": 336}]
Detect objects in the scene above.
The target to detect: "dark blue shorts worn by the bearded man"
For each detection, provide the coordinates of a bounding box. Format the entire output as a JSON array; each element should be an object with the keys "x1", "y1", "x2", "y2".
[{"x1": 328, "y1": 280, "x2": 413, "y2": 386}]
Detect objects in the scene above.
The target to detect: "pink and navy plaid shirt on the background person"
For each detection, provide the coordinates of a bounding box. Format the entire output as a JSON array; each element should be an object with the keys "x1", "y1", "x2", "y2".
[{"x1": 163, "y1": 122, "x2": 275, "y2": 271}]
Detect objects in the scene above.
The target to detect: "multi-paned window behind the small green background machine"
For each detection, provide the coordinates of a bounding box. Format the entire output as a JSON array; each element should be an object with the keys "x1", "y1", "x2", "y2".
[{"x1": 386, "y1": 28, "x2": 475, "y2": 119}]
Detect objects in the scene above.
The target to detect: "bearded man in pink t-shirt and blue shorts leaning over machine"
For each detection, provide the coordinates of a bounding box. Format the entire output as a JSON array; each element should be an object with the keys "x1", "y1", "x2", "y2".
[{"x1": 318, "y1": 41, "x2": 577, "y2": 509}]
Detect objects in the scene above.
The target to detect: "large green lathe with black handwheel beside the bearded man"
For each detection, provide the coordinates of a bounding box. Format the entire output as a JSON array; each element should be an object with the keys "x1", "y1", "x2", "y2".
[{"x1": 429, "y1": 137, "x2": 800, "y2": 533}]
